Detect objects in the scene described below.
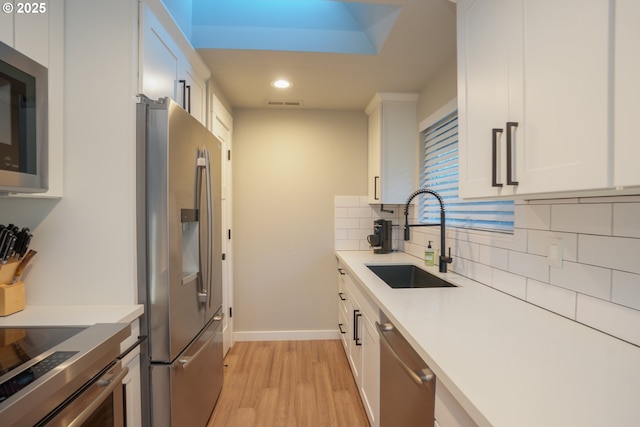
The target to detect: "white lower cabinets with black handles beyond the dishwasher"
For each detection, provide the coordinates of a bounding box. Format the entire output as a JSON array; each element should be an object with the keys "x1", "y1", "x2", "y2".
[{"x1": 338, "y1": 265, "x2": 380, "y2": 427}]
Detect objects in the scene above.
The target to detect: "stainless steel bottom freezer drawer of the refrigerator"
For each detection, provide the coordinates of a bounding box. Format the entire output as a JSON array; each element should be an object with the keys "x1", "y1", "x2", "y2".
[{"x1": 151, "y1": 313, "x2": 223, "y2": 427}]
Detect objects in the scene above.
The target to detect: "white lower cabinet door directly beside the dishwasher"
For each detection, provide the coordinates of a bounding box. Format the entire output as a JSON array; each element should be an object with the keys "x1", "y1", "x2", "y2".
[{"x1": 360, "y1": 315, "x2": 380, "y2": 427}]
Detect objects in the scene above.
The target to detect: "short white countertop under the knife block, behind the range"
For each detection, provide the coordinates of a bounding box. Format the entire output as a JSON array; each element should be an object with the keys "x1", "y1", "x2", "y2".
[{"x1": 0, "y1": 304, "x2": 144, "y2": 327}]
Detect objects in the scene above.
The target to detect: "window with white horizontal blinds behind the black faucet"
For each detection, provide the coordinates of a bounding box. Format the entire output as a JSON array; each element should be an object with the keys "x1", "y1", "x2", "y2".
[{"x1": 418, "y1": 110, "x2": 513, "y2": 233}]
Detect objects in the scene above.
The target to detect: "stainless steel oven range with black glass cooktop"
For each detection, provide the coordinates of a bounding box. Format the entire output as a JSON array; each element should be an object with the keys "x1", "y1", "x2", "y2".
[{"x1": 0, "y1": 324, "x2": 131, "y2": 427}]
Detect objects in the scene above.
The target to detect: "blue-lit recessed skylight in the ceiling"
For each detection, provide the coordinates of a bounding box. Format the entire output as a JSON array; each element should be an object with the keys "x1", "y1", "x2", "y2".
[{"x1": 163, "y1": 0, "x2": 401, "y2": 55}]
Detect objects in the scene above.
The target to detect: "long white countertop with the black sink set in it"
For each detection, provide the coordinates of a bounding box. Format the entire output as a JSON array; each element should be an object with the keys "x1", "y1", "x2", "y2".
[{"x1": 337, "y1": 251, "x2": 640, "y2": 427}]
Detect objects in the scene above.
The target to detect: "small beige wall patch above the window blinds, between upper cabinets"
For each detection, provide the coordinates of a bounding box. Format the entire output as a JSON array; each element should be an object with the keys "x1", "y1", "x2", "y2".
[{"x1": 418, "y1": 57, "x2": 458, "y2": 123}]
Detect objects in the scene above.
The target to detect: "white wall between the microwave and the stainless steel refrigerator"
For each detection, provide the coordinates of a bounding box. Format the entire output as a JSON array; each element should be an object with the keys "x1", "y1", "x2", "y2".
[{"x1": 0, "y1": 0, "x2": 138, "y2": 305}]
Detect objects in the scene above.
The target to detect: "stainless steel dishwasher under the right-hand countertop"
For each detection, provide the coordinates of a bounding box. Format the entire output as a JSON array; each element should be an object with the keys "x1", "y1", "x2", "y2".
[{"x1": 376, "y1": 313, "x2": 436, "y2": 427}]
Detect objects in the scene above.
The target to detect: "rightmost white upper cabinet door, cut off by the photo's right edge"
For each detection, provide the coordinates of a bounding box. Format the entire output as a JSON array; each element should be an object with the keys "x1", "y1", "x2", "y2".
[{"x1": 614, "y1": 0, "x2": 640, "y2": 186}]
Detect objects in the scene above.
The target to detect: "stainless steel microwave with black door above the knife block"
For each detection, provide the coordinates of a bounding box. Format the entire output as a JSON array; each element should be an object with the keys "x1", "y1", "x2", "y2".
[{"x1": 0, "y1": 42, "x2": 49, "y2": 193}]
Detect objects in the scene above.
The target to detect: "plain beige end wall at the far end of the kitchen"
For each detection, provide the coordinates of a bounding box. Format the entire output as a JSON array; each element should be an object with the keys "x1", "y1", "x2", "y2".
[{"x1": 232, "y1": 109, "x2": 367, "y2": 339}]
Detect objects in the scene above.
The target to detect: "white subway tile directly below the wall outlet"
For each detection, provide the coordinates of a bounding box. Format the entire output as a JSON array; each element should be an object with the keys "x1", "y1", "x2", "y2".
[{"x1": 550, "y1": 262, "x2": 611, "y2": 300}]
